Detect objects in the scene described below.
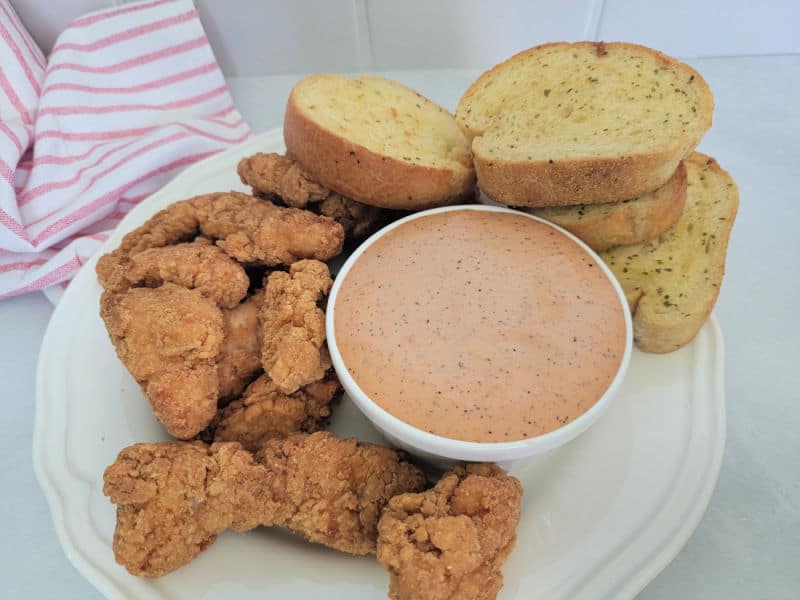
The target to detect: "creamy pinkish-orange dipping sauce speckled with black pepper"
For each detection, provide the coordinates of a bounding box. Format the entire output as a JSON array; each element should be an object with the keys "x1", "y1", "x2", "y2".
[{"x1": 334, "y1": 209, "x2": 625, "y2": 442}]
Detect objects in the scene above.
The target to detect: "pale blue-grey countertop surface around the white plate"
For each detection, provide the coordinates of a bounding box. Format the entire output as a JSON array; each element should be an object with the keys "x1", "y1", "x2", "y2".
[{"x1": 6, "y1": 55, "x2": 800, "y2": 600}]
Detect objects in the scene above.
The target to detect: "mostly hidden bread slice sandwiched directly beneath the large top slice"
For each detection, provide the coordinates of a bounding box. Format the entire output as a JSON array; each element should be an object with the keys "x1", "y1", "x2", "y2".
[{"x1": 523, "y1": 162, "x2": 687, "y2": 252}]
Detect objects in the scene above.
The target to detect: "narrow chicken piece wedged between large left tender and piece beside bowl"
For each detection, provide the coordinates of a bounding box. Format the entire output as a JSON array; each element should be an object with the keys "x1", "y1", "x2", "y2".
[{"x1": 217, "y1": 289, "x2": 264, "y2": 400}]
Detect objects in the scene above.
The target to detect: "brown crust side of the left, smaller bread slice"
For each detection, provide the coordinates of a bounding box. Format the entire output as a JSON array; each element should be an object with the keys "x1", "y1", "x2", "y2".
[{"x1": 283, "y1": 79, "x2": 475, "y2": 210}]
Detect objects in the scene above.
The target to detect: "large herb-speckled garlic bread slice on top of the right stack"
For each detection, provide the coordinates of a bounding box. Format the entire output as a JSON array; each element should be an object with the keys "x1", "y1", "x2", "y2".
[{"x1": 456, "y1": 42, "x2": 714, "y2": 207}]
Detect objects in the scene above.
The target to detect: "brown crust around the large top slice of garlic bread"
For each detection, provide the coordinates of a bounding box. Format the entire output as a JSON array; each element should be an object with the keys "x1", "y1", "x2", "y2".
[{"x1": 456, "y1": 42, "x2": 713, "y2": 207}]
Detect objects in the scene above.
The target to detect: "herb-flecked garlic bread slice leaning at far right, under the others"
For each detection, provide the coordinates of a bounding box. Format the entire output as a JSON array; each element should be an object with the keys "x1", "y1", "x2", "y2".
[{"x1": 600, "y1": 152, "x2": 739, "y2": 352}]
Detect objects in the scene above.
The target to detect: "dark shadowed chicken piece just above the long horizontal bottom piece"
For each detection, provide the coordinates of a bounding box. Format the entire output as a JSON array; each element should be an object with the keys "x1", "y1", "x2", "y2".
[{"x1": 213, "y1": 371, "x2": 341, "y2": 452}]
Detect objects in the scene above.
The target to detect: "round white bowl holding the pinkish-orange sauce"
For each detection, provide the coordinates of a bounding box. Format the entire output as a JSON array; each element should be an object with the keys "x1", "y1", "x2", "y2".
[{"x1": 325, "y1": 204, "x2": 633, "y2": 470}]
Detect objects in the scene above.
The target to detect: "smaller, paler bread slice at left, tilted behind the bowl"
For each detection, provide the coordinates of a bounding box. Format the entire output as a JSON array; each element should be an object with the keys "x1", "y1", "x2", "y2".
[{"x1": 283, "y1": 75, "x2": 475, "y2": 210}]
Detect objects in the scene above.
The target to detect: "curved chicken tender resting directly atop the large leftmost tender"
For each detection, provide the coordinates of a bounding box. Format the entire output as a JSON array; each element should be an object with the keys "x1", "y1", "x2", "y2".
[{"x1": 100, "y1": 240, "x2": 250, "y2": 308}]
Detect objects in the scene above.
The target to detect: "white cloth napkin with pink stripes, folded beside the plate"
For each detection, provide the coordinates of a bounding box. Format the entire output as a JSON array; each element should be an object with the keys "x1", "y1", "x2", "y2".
[{"x1": 0, "y1": 0, "x2": 250, "y2": 302}]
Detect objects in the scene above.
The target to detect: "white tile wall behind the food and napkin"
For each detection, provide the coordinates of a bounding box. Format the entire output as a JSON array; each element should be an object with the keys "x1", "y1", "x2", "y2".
[{"x1": 7, "y1": 0, "x2": 800, "y2": 75}]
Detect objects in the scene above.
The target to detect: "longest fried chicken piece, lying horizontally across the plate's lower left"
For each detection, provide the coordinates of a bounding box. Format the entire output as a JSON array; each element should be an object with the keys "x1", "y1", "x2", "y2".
[{"x1": 103, "y1": 432, "x2": 423, "y2": 577}]
